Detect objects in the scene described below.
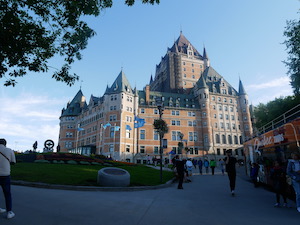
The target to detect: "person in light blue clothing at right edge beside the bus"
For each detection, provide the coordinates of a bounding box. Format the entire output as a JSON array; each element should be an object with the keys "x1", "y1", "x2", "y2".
[{"x1": 286, "y1": 153, "x2": 300, "y2": 212}]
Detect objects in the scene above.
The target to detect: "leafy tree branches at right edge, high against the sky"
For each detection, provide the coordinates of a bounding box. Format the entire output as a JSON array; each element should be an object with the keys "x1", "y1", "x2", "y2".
[{"x1": 284, "y1": 16, "x2": 300, "y2": 95}]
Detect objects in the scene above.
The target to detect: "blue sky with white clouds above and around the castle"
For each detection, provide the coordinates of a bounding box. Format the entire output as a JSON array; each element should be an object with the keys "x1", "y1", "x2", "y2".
[{"x1": 0, "y1": 0, "x2": 300, "y2": 151}]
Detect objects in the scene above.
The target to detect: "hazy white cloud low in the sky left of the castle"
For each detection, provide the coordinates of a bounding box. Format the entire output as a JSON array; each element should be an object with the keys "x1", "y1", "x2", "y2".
[{"x1": 0, "y1": 93, "x2": 66, "y2": 151}]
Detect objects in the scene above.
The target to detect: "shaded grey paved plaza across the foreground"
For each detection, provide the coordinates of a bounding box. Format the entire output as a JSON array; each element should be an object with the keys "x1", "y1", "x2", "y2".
[{"x1": 0, "y1": 168, "x2": 300, "y2": 225}]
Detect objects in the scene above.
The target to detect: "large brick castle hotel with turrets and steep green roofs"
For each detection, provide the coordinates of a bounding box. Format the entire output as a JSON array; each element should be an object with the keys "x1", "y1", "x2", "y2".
[{"x1": 59, "y1": 33, "x2": 252, "y2": 163}]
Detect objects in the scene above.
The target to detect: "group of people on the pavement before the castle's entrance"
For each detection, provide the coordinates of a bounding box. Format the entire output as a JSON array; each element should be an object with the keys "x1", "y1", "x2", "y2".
[{"x1": 174, "y1": 150, "x2": 237, "y2": 196}]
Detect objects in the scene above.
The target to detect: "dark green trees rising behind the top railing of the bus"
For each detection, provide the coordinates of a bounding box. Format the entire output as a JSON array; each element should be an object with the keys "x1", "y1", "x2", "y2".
[{"x1": 254, "y1": 96, "x2": 300, "y2": 128}]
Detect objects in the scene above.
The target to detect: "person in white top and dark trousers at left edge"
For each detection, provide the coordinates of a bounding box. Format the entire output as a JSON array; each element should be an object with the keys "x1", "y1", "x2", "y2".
[{"x1": 0, "y1": 138, "x2": 16, "y2": 219}]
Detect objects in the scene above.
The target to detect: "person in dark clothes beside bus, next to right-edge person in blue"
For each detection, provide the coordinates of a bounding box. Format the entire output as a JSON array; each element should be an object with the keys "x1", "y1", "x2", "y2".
[{"x1": 270, "y1": 161, "x2": 288, "y2": 207}]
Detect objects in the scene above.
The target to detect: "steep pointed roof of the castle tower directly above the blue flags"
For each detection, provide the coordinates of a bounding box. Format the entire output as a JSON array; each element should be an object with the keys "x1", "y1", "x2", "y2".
[{"x1": 104, "y1": 71, "x2": 133, "y2": 94}]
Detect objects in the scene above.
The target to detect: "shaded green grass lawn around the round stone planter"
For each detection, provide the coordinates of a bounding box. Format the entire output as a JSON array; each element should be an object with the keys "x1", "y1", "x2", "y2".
[{"x1": 11, "y1": 163, "x2": 174, "y2": 186}]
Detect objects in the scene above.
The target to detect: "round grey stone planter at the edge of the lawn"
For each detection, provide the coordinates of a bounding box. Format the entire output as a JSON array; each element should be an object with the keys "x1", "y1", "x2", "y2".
[{"x1": 97, "y1": 167, "x2": 130, "y2": 187}]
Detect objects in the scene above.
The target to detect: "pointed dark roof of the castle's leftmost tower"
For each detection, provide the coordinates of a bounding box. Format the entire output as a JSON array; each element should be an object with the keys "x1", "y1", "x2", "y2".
[{"x1": 61, "y1": 90, "x2": 87, "y2": 116}]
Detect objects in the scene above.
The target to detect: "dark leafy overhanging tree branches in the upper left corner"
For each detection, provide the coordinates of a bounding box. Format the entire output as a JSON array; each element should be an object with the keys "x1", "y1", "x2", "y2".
[{"x1": 0, "y1": 0, "x2": 159, "y2": 86}]
